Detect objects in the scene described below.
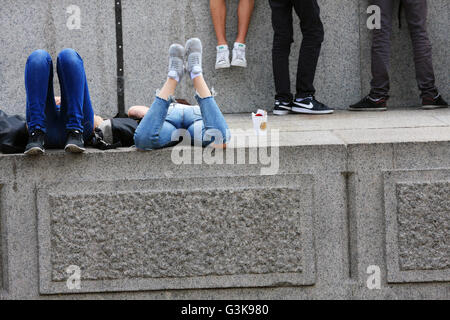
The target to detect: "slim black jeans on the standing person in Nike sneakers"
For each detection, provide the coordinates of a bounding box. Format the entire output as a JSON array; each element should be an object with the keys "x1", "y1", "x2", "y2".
[{"x1": 269, "y1": 0, "x2": 324, "y2": 101}]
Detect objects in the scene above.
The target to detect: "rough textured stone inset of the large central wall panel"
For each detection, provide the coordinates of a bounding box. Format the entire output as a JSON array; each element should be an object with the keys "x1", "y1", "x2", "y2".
[{"x1": 50, "y1": 189, "x2": 304, "y2": 281}]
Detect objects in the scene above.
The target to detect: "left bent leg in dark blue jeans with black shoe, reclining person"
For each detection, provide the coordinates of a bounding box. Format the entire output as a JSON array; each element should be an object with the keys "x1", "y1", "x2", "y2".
[{"x1": 25, "y1": 50, "x2": 57, "y2": 155}]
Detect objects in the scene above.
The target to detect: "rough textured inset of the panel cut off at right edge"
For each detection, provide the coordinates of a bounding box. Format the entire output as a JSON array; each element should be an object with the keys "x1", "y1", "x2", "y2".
[{"x1": 397, "y1": 182, "x2": 450, "y2": 270}]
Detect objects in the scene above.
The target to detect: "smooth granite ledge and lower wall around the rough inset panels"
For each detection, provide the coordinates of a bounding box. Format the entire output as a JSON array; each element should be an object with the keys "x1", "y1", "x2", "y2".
[{"x1": 0, "y1": 110, "x2": 450, "y2": 300}]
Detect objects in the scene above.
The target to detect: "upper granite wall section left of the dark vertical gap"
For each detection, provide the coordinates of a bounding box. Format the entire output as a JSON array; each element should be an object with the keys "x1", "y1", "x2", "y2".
[{"x1": 0, "y1": 0, "x2": 117, "y2": 116}]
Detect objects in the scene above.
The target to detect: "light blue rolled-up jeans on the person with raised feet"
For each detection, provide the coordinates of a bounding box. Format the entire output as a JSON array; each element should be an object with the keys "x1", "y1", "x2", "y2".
[{"x1": 134, "y1": 96, "x2": 229, "y2": 150}]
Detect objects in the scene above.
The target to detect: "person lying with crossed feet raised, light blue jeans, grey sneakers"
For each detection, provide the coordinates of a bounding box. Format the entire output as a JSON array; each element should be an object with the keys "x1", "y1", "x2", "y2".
[{"x1": 133, "y1": 38, "x2": 229, "y2": 151}]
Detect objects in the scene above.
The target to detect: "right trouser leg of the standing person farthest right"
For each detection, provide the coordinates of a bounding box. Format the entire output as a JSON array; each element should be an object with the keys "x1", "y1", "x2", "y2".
[{"x1": 403, "y1": 0, "x2": 439, "y2": 99}]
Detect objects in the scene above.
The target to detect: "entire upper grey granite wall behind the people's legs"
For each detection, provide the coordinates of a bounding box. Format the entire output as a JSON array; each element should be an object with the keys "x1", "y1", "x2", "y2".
[{"x1": 0, "y1": 0, "x2": 450, "y2": 116}]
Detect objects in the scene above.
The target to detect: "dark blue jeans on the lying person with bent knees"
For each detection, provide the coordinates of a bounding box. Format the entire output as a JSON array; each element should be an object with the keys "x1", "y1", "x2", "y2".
[{"x1": 25, "y1": 49, "x2": 94, "y2": 148}]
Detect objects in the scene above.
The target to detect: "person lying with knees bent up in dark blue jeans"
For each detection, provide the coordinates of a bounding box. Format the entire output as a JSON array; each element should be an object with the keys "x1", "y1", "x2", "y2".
[{"x1": 22, "y1": 49, "x2": 144, "y2": 155}]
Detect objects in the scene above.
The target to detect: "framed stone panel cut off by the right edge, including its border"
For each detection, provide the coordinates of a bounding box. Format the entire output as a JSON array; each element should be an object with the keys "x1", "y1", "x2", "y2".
[{"x1": 384, "y1": 170, "x2": 450, "y2": 282}]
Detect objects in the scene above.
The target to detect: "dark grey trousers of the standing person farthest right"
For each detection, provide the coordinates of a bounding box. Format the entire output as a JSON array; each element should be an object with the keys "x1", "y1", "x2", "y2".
[{"x1": 370, "y1": 0, "x2": 438, "y2": 98}]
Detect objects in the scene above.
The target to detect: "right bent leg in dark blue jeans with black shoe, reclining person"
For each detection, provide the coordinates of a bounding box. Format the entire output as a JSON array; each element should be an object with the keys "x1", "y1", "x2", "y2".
[{"x1": 57, "y1": 49, "x2": 94, "y2": 153}]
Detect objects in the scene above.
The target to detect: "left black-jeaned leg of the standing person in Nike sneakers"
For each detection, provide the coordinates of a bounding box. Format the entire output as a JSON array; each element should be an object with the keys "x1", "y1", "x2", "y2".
[{"x1": 269, "y1": 0, "x2": 294, "y2": 103}]
